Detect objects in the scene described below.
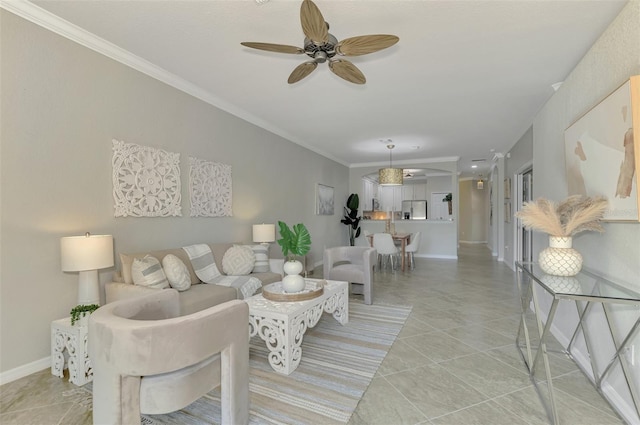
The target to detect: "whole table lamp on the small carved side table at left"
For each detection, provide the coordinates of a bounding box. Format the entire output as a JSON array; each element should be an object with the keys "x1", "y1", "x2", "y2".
[{"x1": 60, "y1": 232, "x2": 113, "y2": 305}]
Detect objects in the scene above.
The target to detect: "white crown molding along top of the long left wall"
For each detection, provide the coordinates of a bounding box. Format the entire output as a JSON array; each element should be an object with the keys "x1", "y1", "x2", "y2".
[{"x1": 0, "y1": 0, "x2": 349, "y2": 167}]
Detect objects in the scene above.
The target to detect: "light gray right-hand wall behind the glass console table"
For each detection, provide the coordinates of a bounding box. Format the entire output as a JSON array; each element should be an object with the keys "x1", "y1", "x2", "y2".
[{"x1": 533, "y1": 1, "x2": 640, "y2": 423}]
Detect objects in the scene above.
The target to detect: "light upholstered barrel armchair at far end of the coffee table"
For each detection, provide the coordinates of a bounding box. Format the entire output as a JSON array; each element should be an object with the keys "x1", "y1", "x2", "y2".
[{"x1": 322, "y1": 246, "x2": 378, "y2": 304}]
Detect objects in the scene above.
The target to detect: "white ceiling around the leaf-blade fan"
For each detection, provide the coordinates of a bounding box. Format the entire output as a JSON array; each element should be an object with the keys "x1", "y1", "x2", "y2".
[{"x1": 23, "y1": 0, "x2": 626, "y2": 176}]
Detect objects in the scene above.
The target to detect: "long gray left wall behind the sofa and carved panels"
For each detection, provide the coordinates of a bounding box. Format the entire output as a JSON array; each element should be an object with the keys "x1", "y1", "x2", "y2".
[{"x1": 0, "y1": 9, "x2": 349, "y2": 372}]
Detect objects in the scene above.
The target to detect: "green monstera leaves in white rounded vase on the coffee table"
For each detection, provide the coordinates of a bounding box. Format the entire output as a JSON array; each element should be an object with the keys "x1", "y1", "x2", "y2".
[{"x1": 278, "y1": 221, "x2": 311, "y2": 292}]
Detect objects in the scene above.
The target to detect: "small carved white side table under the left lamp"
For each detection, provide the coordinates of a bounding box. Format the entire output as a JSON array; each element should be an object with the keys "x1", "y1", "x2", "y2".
[{"x1": 51, "y1": 317, "x2": 93, "y2": 386}]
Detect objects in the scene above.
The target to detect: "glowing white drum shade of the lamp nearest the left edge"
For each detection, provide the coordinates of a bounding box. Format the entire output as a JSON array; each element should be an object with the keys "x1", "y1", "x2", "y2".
[{"x1": 60, "y1": 233, "x2": 113, "y2": 272}]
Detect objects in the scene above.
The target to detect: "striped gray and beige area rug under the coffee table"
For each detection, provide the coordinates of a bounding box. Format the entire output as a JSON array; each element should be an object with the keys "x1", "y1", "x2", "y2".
[{"x1": 142, "y1": 301, "x2": 411, "y2": 425}]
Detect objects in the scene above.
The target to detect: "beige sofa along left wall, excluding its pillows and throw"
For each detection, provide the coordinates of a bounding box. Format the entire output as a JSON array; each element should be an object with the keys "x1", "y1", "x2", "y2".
[{"x1": 105, "y1": 243, "x2": 284, "y2": 315}]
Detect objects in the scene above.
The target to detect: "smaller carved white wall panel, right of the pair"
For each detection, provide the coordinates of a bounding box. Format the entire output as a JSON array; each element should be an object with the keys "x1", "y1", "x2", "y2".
[{"x1": 189, "y1": 157, "x2": 233, "y2": 217}]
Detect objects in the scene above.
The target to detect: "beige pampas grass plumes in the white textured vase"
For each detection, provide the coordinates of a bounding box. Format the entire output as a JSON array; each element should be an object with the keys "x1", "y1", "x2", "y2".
[{"x1": 515, "y1": 195, "x2": 608, "y2": 237}]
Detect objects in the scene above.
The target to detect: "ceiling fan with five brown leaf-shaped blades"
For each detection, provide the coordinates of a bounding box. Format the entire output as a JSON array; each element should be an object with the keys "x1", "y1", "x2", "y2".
[{"x1": 240, "y1": 0, "x2": 399, "y2": 84}]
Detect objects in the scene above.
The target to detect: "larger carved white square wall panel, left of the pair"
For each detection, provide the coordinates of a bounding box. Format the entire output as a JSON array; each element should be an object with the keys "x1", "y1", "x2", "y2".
[{"x1": 113, "y1": 140, "x2": 182, "y2": 217}]
